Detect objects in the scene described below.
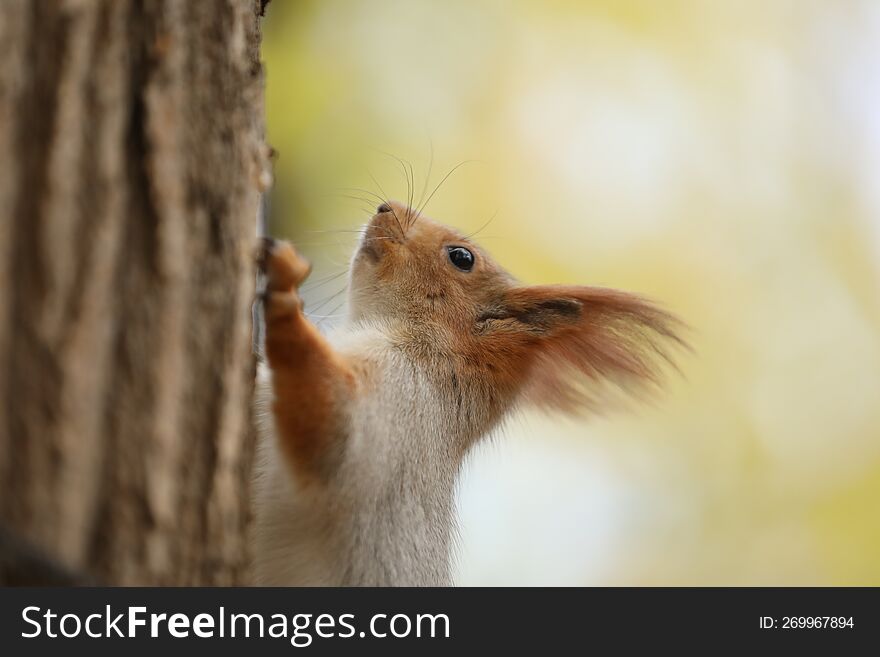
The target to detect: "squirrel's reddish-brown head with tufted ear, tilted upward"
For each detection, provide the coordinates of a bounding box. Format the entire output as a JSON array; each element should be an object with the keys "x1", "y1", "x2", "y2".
[{"x1": 351, "y1": 202, "x2": 683, "y2": 410}]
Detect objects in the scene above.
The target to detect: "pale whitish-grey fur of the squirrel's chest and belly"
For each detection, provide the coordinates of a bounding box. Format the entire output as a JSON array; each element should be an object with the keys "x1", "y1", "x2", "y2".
[{"x1": 252, "y1": 329, "x2": 459, "y2": 586}]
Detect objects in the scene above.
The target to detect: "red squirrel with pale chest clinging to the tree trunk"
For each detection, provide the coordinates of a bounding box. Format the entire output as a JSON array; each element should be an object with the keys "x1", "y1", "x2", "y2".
[{"x1": 252, "y1": 202, "x2": 685, "y2": 586}]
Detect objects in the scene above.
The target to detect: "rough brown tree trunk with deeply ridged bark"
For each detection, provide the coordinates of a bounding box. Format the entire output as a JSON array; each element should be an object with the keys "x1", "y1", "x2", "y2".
[{"x1": 0, "y1": 0, "x2": 268, "y2": 585}]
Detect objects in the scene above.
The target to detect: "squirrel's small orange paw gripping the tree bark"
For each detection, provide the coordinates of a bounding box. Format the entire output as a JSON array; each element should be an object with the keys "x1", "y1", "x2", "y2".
[{"x1": 257, "y1": 237, "x2": 312, "y2": 317}]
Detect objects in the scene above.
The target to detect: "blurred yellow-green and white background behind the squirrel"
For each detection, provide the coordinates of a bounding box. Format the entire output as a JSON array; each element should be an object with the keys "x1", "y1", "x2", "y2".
[{"x1": 263, "y1": 0, "x2": 880, "y2": 585}]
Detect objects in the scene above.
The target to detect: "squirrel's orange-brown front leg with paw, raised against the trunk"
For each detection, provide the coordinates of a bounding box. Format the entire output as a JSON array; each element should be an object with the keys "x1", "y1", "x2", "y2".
[{"x1": 260, "y1": 238, "x2": 355, "y2": 479}]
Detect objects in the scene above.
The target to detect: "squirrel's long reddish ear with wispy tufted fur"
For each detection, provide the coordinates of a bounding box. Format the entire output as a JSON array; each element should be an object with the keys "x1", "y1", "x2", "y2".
[{"x1": 477, "y1": 285, "x2": 684, "y2": 411}]
